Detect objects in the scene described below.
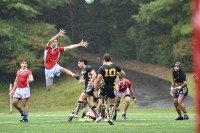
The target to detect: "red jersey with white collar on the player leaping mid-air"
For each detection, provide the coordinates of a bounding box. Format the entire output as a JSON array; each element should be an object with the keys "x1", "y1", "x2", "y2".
[{"x1": 44, "y1": 46, "x2": 64, "y2": 69}]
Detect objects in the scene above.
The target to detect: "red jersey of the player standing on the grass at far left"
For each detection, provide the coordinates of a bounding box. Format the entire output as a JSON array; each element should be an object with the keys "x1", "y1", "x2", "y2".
[{"x1": 16, "y1": 69, "x2": 32, "y2": 88}]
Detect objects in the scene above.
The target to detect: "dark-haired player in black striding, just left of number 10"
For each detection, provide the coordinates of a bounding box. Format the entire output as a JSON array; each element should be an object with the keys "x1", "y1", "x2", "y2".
[{"x1": 68, "y1": 58, "x2": 98, "y2": 121}]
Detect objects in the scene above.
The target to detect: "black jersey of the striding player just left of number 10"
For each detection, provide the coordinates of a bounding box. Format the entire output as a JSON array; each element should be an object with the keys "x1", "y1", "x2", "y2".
[{"x1": 81, "y1": 65, "x2": 94, "y2": 86}]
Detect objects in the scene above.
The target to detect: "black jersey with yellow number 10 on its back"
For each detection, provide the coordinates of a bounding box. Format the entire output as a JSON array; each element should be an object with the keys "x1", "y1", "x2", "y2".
[{"x1": 98, "y1": 64, "x2": 122, "y2": 86}]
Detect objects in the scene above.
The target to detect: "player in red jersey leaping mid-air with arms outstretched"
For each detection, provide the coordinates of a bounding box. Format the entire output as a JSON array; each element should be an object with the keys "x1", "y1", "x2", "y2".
[{"x1": 44, "y1": 29, "x2": 88, "y2": 91}]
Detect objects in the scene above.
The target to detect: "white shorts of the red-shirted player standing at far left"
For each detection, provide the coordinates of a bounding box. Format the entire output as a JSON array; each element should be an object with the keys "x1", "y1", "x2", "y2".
[{"x1": 13, "y1": 87, "x2": 30, "y2": 99}]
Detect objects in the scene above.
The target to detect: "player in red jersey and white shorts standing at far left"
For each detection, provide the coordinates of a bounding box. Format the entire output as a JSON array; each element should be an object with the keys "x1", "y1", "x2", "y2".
[{"x1": 10, "y1": 60, "x2": 33, "y2": 122}]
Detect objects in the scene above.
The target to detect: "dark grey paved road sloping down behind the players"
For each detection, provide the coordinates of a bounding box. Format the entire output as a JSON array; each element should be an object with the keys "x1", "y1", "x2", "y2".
[{"x1": 68, "y1": 59, "x2": 194, "y2": 108}]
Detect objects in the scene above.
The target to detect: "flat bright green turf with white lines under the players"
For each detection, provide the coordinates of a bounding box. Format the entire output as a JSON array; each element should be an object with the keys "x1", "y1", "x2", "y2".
[{"x1": 0, "y1": 109, "x2": 195, "y2": 133}]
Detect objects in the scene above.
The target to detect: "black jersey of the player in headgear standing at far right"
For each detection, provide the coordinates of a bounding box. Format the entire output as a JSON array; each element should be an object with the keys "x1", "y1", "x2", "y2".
[{"x1": 173, "y1": 70, "x2": 186, "y2": 83}]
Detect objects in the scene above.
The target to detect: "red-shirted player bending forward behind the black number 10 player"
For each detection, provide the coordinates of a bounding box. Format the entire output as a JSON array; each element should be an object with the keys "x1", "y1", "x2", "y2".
[{"x1": 116, "y1": 78, "x2": 136, "y2": 119}]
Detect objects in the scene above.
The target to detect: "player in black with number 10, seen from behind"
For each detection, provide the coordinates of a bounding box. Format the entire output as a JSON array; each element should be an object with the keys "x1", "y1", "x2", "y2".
[{"x1": 95, "y1": 54, "x2": 126, "y2": 125}]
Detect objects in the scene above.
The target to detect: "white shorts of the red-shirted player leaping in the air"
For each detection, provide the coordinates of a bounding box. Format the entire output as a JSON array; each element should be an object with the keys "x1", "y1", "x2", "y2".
[{"x1": 45, "y1": 64, "x2": 61, "y2": 86}]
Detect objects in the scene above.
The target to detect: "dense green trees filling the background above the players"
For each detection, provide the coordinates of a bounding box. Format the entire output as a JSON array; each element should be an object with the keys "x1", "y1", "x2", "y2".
[{"x1": 0, "y1": 0, "x2": 192, "y2": 81}]
